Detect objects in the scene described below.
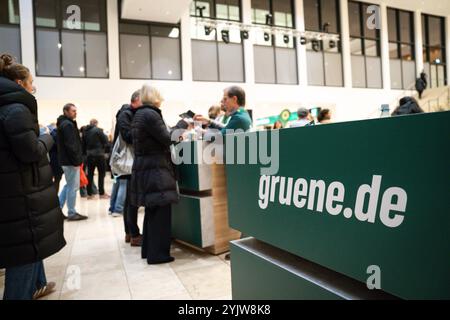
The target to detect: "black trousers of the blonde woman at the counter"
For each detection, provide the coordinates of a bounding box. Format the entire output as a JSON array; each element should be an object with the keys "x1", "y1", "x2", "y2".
[{"x1": 142, "y1": 204, "x2": 172, "y2": 263}]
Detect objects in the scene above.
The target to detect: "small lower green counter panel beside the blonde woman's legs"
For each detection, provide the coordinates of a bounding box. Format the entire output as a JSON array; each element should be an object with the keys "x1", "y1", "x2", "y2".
[{"x1": 172, "y1": 195, "x2": 203, "y2": 248}]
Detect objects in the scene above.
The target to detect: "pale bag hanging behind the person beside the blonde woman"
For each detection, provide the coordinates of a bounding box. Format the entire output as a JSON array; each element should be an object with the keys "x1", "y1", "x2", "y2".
[{"x1": 109, "y1": 134, "x2": 134, "y2": 177}]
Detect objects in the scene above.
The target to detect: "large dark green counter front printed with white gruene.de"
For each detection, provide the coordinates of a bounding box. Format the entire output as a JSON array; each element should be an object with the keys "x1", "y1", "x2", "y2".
[{"x1": 226, "y1": 112, "x2": 450, "y2": 299}]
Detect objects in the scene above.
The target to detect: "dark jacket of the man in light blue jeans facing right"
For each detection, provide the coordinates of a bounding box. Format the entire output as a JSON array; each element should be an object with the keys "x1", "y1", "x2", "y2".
[{"x1": 56, "y1": 115, "x2": 83, "y2": 167}]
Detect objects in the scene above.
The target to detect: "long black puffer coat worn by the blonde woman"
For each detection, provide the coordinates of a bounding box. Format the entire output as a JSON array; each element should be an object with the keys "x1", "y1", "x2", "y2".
[{"x1": 130, "y1": 106, "x2": 185, "y2": 207}]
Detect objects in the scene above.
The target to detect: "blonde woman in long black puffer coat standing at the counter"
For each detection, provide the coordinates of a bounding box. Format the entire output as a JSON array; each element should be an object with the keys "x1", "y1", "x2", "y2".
[{"x1": 130, "y1": 85, "x2": 188, "y2": 264}]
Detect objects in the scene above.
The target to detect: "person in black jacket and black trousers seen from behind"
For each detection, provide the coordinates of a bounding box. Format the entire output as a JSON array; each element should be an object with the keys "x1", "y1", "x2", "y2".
[{"x1": 82, "y1": 119, "x2": 109, "y2": 199}]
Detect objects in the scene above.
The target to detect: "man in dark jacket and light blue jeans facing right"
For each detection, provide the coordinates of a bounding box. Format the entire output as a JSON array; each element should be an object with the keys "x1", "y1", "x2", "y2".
[{"x1": 57, "y1": 103, "x2": 87, "y2": 221}]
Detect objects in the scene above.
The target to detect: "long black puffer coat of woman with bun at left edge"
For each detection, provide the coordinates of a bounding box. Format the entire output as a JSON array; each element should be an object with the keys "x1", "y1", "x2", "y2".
[{"x1": 0, "y1": 77, "x2": 66, "y2": 268}]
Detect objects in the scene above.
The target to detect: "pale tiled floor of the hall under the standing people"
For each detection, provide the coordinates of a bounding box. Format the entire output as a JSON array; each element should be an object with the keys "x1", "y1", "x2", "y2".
[{"x1": 0, "y1": 179, "x2": 231, "y2": 300}]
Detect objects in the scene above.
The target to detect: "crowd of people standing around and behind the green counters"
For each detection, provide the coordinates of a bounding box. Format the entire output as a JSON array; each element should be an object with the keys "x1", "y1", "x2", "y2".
[{"x1": 0, "y1": 54, "x2": 422, "y2": 300}]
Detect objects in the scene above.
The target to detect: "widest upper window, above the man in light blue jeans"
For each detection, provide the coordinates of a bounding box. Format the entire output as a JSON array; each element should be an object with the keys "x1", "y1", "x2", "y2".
[{"x1": 33, "y1": 0, "x2": 109, "y2": 78}]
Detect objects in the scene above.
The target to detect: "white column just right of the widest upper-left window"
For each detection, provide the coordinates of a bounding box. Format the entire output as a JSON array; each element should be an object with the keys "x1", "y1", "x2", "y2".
[{"x1": 107, "y1": 0, "x2": 120, "y2": 80}]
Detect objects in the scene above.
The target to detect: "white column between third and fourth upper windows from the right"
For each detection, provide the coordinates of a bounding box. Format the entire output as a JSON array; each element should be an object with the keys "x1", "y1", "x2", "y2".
[{"x1": 339, "y1": 0, "x2": 353, "y2": 88}]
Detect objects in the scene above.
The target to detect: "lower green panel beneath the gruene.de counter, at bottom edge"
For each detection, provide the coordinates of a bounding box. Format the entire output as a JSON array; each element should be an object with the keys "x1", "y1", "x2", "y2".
[{"x1": 230, "y1": 242, "x2": 342, "y2": 300}]
